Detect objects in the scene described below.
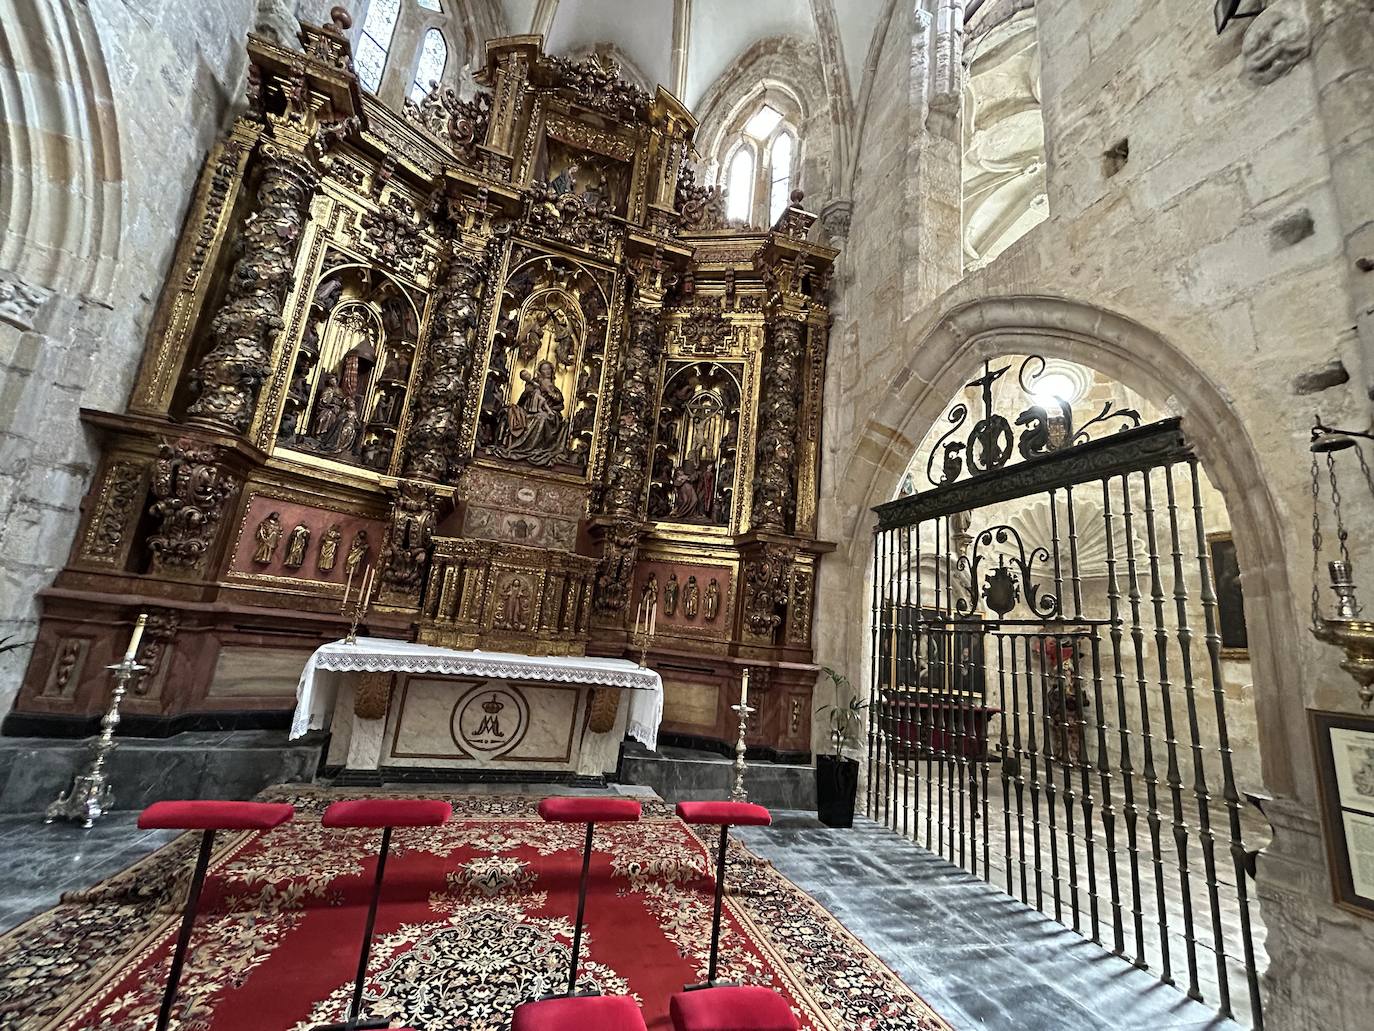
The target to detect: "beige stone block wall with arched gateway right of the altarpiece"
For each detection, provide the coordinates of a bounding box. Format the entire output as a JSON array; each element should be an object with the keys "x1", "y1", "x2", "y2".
[{"x1": 816, "y1": 0, "x2": 1374, "y2": 1027}]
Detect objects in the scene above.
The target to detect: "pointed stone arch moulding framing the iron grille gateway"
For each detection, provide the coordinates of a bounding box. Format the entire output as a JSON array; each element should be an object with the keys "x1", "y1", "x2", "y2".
[{"x1": 835, "y1": 296, "x2": 1314, "y2": 797}]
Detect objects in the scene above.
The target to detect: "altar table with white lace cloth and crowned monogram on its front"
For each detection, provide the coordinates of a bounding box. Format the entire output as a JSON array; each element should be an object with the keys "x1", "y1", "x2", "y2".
[{"x1": 291, "y1": 638, "x2": 664, "y2": 779}]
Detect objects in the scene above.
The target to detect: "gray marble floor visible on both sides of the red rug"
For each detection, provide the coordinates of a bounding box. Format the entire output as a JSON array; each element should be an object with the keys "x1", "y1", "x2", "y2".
[{"x1": 0, "y1": 785, "x2": 1237, "y2": 1031}]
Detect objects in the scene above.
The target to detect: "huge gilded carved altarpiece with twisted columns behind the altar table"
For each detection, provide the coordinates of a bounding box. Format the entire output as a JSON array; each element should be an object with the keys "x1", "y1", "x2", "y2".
[{"x1": 8, "y1": 16, "x2": 835, "y2": 755}]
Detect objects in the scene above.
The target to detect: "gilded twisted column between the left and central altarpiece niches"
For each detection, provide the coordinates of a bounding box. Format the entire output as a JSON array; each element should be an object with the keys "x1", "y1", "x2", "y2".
[{"x1": 405, "y1": 244, "x2": 493, "y2": 483}]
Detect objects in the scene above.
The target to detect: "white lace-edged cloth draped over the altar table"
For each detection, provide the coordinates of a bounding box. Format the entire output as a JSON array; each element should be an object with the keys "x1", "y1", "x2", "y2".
[{"x1": 291, "y1": 638, "x2": 664, "y2": 752}]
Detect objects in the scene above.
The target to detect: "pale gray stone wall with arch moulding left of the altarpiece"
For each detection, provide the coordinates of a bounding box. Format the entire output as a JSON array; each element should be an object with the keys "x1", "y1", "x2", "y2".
[{"x1": 0, "y1": 0, "x2": 303, "y2": 709}]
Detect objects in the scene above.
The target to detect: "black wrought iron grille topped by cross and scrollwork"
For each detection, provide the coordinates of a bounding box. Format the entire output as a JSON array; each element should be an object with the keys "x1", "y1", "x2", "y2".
[{"x1": 867, "y1": 357, "x2": 1263, "y2": 1028}]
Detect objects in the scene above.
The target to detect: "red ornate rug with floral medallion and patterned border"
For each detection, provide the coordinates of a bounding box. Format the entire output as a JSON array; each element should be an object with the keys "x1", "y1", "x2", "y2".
[{"x1": 0, "y1": 789, "x2": 948, "y2": 1031}]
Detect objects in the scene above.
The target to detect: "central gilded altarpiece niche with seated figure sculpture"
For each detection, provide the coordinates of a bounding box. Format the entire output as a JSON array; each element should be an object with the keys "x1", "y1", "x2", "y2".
[{"x1": 477, "y1": 249, "x2": 609, "y2": 474}]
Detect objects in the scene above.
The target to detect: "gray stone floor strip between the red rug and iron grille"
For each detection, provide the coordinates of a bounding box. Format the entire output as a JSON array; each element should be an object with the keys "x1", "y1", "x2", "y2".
[{"x1": 735, "y1": 812, "x2": 1238, "y2": 1031}]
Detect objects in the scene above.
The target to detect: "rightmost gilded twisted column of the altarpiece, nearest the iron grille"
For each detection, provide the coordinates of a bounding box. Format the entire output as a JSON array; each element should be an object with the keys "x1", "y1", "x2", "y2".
[{"x1": 753, "y1": 313, "x2": 805, "y2": 533}]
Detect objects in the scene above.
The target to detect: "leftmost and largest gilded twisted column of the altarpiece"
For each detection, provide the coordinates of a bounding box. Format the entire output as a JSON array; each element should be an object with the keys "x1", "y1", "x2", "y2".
[{"x1": 187, "y1": 144, "x2": 317, "y2": 432}]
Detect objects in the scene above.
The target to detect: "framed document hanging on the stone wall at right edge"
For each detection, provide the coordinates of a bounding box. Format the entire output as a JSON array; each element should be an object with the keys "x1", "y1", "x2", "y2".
[{"x1": 1311, "y1": 711, "x2": 1374, "y2": 917}]
